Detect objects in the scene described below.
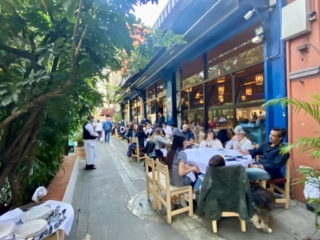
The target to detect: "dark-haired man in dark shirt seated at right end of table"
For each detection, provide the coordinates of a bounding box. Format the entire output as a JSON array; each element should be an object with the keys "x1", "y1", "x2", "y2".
[{"x1": 238, "y1": 127, "x2": 290, "y2": 180}]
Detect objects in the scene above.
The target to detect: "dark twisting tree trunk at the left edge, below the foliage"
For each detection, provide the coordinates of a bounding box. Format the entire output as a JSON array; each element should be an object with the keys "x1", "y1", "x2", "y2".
[{"x1": 0, "y1": 105, "x2": 44, "y2": 207}]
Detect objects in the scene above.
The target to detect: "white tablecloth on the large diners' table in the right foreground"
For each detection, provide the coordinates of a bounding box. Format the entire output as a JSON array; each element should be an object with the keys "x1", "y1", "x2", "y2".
[{"x1": 185, "y1": 148, "x2": 254, "y2": 181}]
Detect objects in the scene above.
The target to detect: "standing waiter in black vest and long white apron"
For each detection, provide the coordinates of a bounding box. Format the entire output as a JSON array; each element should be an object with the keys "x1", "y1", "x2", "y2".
[{"x1": 83, "y1": 116, "x2": 98, "y2": 170}]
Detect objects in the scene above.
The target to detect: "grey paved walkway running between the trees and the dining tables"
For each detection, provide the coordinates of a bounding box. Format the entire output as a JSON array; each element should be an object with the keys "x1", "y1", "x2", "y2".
[{"x1": 66, "y1": 138, "x2": 320, "y2": 240}]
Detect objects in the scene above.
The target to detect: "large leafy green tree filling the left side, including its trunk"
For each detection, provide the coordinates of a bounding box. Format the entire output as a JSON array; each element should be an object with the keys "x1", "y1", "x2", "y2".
[{"x1": 0, "y1": 0, "x2": 157, "y2": 207}]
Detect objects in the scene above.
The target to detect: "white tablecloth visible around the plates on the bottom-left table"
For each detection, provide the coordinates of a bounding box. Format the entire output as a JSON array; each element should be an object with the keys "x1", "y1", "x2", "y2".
[{"x1": 0, "y1": 200, "x2": 74, "y2": 238}]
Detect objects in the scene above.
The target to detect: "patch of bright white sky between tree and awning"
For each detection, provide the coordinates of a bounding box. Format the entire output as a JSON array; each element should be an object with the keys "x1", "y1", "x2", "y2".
[{"x1": 134, "y1": 0, "x2": 169, "y2": 27}]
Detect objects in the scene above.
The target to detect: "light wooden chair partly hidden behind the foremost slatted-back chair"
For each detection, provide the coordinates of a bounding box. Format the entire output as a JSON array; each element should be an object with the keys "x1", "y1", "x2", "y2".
[{"x1": 144, "y1": 154, "x2": 164, "y2": 209}]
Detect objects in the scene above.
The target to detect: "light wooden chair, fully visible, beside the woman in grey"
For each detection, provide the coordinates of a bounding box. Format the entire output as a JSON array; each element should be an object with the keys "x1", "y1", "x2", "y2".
[{"x1": 156, "y1": 160, "x2": 193, "y2": 224}]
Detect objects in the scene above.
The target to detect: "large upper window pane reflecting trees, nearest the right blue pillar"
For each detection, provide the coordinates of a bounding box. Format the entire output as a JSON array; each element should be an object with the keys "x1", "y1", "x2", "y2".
[{"x1": 208, "y1": 44, "x2": 264, "y2": 79}]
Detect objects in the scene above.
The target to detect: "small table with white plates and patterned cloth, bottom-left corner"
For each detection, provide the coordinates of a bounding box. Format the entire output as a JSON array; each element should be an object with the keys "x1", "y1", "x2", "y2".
[{"x1": 0, "y1": 200, "x2": 74, "y2": 240}]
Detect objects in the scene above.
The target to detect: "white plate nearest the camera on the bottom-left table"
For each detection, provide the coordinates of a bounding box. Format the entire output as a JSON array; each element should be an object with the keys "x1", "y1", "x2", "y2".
[{"x1": 14, "y1": 219, "x2": 48, "y2": 238}]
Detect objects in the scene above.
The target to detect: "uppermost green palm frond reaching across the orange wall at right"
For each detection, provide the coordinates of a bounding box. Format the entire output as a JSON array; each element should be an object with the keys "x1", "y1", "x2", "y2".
[{"x1": 263, "y1": 95, "x2": 320, "y2": 123}]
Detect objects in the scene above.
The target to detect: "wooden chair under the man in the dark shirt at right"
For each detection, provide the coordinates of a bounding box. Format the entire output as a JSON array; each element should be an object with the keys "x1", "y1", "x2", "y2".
[{"x1": 261, "y1": 159, "x2": 290, "y2": 209}]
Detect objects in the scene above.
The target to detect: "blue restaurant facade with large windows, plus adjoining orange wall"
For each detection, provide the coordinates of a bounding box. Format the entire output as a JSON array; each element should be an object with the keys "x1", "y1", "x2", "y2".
[{"x1": 121, "y1": 0, "x2": 320, "y2": 200}]
